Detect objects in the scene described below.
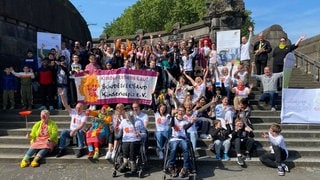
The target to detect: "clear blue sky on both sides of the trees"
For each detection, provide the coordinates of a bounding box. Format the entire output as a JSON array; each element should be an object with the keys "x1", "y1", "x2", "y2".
[{"x1": 70, "y1": 0, "x2": 320, "y2": 42}]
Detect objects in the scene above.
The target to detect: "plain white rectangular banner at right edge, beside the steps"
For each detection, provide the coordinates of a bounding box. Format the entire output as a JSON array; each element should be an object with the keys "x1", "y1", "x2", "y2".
[{"x1": 281, "y1": 88, "x2": 320, "y2": 124}]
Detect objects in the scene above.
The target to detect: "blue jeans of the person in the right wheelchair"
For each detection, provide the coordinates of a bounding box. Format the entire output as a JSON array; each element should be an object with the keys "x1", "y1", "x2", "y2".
[{"x1": 168, "y1": 140, "x2": 190, "y2": 168}]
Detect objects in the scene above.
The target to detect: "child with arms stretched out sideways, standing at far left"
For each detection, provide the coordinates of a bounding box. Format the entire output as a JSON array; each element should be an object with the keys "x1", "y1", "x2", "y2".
[{"x1": 11, "y1": 66, "x2": 34, "y2": 110}]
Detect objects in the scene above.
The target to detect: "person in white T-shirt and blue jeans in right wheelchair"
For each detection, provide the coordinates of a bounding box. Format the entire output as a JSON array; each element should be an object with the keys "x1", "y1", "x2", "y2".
[{"x1": 164, "y1": 106, "x2": 196, "y2": 178}]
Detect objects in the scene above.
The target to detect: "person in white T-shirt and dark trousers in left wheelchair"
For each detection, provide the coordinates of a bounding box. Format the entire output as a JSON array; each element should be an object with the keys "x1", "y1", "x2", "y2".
[{"x1": 115, "y1": 109, "x2": 146, "y2": 173}]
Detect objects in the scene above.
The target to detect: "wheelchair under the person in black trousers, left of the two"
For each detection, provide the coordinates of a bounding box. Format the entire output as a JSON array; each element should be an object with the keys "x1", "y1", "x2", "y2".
[{"x1": 112, "y1": 140, "x2": 147, "y2": 178}]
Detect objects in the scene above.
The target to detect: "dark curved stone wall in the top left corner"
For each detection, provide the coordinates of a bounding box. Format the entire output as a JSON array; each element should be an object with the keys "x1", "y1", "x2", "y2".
[{"x1": 0, "y1": 0, "x2": 91, "y2": 69}]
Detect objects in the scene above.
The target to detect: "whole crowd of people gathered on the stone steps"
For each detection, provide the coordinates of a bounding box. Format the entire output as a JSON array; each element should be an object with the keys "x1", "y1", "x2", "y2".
[{"x1": 12, "y1": 27, "x2": 304, "y2": 177}]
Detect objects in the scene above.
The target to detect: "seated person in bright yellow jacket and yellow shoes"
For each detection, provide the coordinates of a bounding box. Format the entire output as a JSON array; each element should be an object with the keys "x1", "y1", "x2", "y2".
[{"x1": 20, "y1": 110, "x2": 58, "y2": 168}]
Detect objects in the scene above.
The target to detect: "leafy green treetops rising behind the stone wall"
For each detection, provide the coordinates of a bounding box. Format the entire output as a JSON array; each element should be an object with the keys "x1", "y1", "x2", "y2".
[{"x1": 103, "y1": 0, "x2": 253, "y2": 37}]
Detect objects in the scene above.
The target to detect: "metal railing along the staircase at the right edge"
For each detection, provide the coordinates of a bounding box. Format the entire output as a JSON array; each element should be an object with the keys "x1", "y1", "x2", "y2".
[{"x1": 294, "y1": 51, "x2": 320, "y2": 82}]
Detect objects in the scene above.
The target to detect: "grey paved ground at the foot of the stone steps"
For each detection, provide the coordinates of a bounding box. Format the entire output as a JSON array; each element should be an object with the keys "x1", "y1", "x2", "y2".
[{"x1": 0, "y1": 163, "x2": 320, "y2": 180}]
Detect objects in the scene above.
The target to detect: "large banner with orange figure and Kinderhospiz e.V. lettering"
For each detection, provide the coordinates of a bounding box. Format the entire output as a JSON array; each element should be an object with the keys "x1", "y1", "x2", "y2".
[{"x1": 75, "y1": 69, "x2": 157, "y2": 105}]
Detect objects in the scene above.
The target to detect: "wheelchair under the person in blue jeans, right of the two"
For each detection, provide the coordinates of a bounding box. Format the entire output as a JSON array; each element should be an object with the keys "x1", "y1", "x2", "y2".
[{"x1": 163, "y1": 138, "x2": 197, "y2": 180}]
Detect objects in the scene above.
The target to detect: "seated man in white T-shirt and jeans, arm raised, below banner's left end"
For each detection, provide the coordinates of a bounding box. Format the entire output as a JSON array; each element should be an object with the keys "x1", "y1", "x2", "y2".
[{"x1": 56, "y1": 88, "x2": 87, "y2": 158}]
